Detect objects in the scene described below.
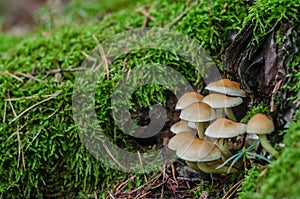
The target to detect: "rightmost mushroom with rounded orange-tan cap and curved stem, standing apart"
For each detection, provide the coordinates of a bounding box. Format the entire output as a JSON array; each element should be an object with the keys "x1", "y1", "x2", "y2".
[{"x1": 247, "y1": 113, "x2": 279, "y2": 158}]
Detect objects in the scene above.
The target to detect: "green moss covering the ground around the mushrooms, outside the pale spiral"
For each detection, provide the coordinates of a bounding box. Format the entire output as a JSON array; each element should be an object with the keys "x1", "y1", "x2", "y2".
[{"x1": 0, "y1": 0, "x2": 300, "y2": 198}]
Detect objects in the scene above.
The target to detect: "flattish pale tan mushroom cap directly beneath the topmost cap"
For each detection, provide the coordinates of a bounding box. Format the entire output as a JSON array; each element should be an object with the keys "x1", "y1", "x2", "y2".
[{"x1": 202, "y1": 93, "x2": 243, "y2": 108}]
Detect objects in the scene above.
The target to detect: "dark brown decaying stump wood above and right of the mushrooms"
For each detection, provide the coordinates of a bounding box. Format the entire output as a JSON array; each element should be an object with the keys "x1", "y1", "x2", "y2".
[{"x1": 223, "y1": 22, "x2": 300, "y2": 126}]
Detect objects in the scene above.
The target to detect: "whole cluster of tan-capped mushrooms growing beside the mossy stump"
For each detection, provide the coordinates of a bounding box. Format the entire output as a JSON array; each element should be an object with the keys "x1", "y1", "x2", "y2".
[{"x1": 168, "y1": 79, "x2": 278, "y2": 174}]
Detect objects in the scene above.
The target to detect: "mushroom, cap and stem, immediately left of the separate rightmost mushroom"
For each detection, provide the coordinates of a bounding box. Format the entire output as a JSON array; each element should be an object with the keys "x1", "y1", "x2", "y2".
[{"x1": 205, "y1": 118, "x2": 246, "y2": 159}]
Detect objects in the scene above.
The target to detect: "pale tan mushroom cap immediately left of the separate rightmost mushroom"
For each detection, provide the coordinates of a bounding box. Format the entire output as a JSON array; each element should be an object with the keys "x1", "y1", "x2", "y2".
[{"x1": 205, "y1": 118, "x2": 246, "y2": 138}]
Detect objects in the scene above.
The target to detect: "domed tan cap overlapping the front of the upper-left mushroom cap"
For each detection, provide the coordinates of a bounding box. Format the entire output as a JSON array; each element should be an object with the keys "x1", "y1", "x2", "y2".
[{"x1": 179, "y1": 102, "x2": 216, "y2": 122}]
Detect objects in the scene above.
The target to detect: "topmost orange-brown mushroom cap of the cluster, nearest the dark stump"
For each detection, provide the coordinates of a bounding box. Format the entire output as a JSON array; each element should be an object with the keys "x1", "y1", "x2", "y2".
[{"x1": 205, "y1": 79, "x2": 246, "y2": 97}]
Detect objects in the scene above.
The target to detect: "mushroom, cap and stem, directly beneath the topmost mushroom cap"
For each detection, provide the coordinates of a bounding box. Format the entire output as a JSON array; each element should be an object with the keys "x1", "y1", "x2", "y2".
[{"x1": 202, "y1": 93, "x2": 243, "y2": 122}]
